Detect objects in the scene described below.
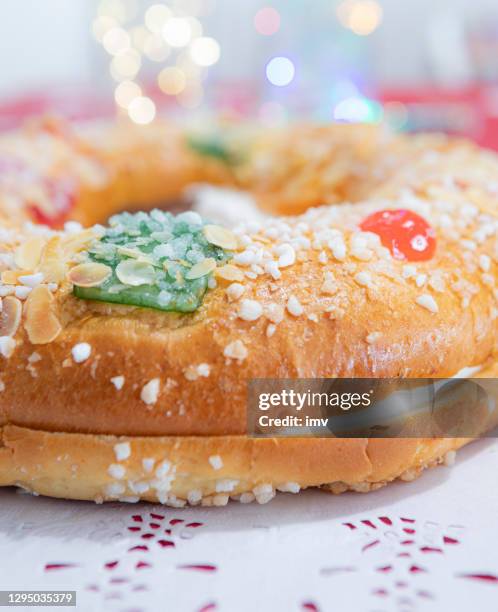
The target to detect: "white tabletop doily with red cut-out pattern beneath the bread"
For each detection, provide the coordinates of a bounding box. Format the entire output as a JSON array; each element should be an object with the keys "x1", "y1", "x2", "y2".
[{"x1": 0, "y1": 440, "x2": 498, "y2": 612}]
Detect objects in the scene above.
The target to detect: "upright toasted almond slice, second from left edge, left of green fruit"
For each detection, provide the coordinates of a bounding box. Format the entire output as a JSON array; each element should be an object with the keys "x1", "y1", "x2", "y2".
[{"x1": 24, "y1": 285, "x2": 62, "y2": 344}]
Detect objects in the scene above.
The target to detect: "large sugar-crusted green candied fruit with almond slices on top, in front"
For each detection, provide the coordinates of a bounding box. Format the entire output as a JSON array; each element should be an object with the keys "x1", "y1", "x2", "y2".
[{"x1": 72, "y1": 210, "x2": 231, "y2": 312}]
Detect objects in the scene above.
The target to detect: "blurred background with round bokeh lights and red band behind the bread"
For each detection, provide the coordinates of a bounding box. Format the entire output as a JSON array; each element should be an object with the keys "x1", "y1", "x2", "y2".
[{"x1": 0, "y1": 0, "x2": 498, "y2": 148}]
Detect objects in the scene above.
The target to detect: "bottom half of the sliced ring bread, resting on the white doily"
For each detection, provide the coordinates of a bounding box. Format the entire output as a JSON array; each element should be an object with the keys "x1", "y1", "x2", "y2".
[{"x1": 0, "y1": 426, "x2": 467, "y2": 506}]
